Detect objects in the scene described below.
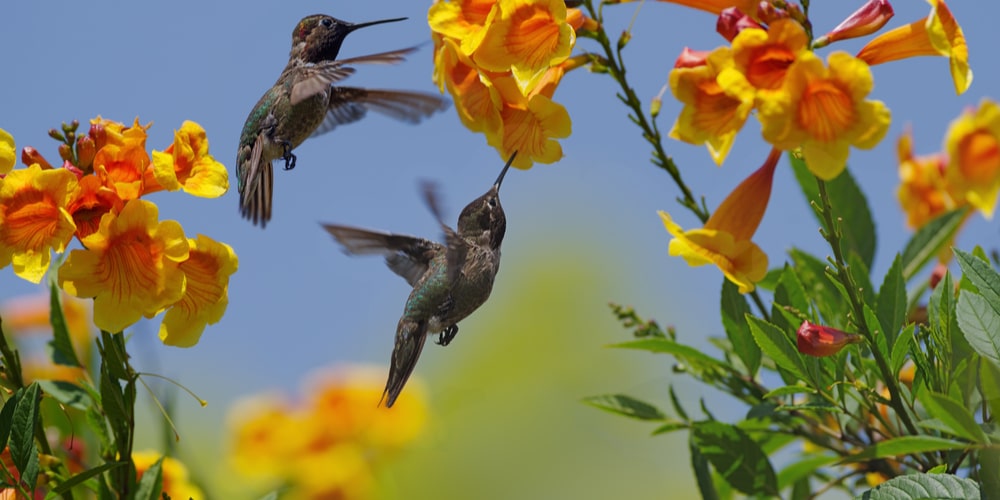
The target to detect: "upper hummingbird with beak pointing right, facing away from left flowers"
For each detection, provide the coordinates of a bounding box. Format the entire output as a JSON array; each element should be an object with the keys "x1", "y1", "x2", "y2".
[{"x1": 236, "y1": 14, "x2": 447, "y2": 227}]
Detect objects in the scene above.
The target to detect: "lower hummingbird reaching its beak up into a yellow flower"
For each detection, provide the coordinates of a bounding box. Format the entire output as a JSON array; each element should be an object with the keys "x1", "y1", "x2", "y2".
[{"x1": 323, "y1": 152, "x2": 517, "y2": 407}]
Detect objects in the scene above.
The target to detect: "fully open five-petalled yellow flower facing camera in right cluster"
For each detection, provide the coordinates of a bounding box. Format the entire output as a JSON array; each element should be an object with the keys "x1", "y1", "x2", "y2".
[{"x1": 758, "y1": 52, "x2": 890, "y2": 180}]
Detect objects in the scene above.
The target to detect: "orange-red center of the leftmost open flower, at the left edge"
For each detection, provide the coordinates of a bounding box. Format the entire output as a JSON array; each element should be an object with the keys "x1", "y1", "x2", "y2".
[{"x1": 0, "y1": 190, "x2": 61, "y2": 250}]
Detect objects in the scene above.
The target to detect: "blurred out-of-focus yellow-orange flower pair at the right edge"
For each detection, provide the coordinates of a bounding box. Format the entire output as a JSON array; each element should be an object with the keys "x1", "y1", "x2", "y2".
[{"x1": 898, "y1": 99, "x2": 1000, "y2": 229}]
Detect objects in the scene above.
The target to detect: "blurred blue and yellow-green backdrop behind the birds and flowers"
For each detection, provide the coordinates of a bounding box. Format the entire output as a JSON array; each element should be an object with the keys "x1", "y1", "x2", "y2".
[{"x1": 0, "y1": 0, "x2": 1000, "y2": 498}]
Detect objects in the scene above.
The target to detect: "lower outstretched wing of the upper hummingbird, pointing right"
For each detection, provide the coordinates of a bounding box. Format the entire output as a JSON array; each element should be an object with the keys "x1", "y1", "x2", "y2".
[{"x1": 310, "y1": 87, "x2": 448, "y2": 137}]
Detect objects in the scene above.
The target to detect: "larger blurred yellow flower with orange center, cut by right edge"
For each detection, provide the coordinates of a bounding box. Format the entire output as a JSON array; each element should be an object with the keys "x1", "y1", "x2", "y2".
[{"x1": 945, "y1": 98, "x2": 1000, "y2": 219}]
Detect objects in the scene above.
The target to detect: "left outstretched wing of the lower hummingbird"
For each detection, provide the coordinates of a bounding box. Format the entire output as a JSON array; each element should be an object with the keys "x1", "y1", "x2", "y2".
[{"x1": 323, "y1": 224, "x2": 444, "y2": 286}]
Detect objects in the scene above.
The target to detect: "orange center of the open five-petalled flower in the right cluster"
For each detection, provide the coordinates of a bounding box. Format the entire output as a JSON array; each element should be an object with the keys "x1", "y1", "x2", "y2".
[{"x1": 798, "y1": 80, "x2": 855, "y2": 142}]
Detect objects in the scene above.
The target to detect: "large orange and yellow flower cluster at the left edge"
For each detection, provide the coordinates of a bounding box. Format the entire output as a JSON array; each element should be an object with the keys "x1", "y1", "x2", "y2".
[{"x1": 0, "y1": 117, "x2": 237, "y2": 346}]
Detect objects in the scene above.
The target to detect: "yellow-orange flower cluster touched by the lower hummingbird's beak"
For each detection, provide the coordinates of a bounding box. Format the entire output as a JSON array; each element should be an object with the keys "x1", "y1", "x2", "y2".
[{"x1": 427, "y1": 0, "x2": 593, "y2": 168}]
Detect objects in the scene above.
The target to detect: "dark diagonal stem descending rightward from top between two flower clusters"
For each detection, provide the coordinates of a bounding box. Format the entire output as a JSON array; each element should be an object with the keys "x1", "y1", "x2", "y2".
[{"x1": 584, "y1": 0, "x2": 709, "y2": 224}]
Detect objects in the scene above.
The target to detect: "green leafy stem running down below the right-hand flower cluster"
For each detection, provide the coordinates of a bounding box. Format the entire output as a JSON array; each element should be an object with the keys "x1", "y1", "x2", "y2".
[{"x1": 816, "y1": 177, "x2": 919, "y2": 435}]
